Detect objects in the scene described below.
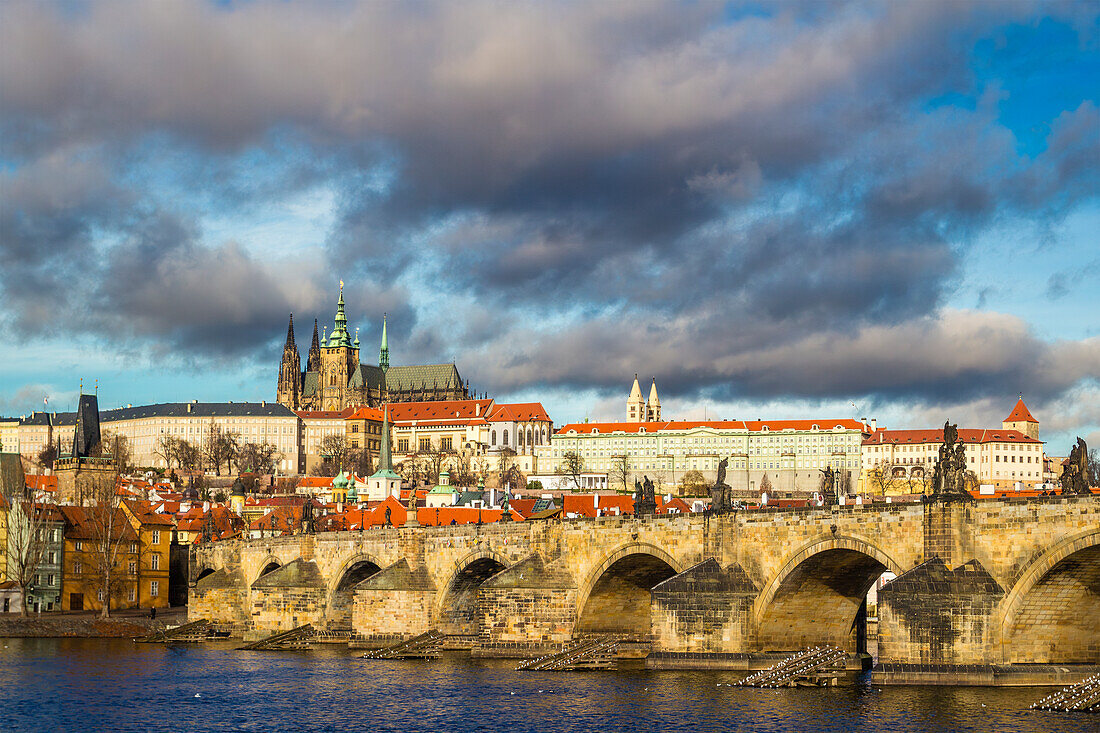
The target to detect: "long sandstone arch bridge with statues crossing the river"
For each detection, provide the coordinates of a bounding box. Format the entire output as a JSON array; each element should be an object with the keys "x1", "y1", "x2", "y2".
[{"x1": 188, "y1": 496, "x2": 1100, "y2": 667}]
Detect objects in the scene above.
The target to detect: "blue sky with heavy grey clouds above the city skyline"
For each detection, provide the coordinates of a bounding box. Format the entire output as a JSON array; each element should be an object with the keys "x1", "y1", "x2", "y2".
[{"x1": 0, "y1": 0, "x2": 1100, "y2": 455}]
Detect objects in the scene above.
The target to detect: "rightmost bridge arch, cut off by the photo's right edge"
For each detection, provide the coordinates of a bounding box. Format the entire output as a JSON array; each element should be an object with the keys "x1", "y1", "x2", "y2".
[{"x1": 994, "y1": 529, "x2": 1100, "y2": 664}]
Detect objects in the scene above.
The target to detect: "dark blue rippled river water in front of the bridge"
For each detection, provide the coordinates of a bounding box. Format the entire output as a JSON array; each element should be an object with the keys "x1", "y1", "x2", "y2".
[{"x1": 0, "y1": 638, "x2": 1100, "y2": 733}]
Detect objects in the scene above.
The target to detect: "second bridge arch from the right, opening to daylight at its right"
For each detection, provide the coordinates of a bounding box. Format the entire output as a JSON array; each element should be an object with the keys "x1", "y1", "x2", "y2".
[{"x1": 752, "y1": 535, "x2": 904, "y2": 652}]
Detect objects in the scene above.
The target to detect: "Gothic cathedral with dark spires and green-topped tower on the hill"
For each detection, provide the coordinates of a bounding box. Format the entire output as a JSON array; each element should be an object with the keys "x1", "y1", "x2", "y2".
[{"x1": 275, "y1": 283, "x2": 470, "y2": 411}]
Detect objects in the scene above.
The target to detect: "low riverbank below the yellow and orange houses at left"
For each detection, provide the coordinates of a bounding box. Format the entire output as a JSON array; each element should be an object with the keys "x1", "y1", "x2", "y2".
[{"x1": 0, "y1": 608, "x2": 187, "y2": 638}]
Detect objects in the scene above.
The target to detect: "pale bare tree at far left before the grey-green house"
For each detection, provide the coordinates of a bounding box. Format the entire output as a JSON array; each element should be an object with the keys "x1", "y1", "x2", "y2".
[{"x1": 0, "y1": 455, "x2": 53, "y2": 616}]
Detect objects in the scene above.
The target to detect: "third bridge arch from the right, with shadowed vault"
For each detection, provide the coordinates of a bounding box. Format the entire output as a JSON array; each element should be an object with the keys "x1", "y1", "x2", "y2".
[{"x1": 574, "y1": 543, "x2": 683, "y2": 637}]
